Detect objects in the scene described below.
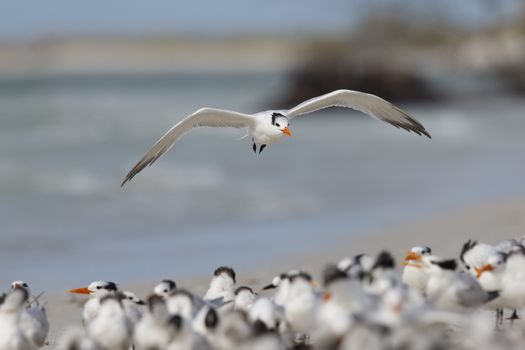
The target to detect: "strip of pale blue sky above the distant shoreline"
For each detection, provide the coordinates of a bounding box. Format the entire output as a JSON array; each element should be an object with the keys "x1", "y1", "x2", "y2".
[{"x1": 0, "y1": 0, "x2": 522, "y2": 39}]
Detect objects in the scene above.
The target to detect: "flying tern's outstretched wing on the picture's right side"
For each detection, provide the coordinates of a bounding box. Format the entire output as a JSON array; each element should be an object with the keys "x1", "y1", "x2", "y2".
[{"x1": 285, "y1": 90, "x2": 431, "y2": 138}]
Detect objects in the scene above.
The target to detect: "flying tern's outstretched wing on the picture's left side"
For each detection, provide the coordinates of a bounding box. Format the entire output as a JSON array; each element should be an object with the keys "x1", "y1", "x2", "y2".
[{"x1": 121, "y1": 108, "x2": 255, "y2": 186}]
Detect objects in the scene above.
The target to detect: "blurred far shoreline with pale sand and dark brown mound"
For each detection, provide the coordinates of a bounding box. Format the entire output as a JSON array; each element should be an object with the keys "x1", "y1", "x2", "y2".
[{"x1": 0, "y1": 18, "x2": 525, "y2": 102}]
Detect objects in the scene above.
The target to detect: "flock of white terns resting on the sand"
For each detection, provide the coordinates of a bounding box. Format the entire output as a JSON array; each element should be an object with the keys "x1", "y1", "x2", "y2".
[{"x1": 0, "y1": 237, "x2": 525, "y2": 350}]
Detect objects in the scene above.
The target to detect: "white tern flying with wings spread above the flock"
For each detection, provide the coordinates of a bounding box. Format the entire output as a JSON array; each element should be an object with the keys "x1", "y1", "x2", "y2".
[{"x1": 121, "y1": 90, "x2": 431, "y2": 186}]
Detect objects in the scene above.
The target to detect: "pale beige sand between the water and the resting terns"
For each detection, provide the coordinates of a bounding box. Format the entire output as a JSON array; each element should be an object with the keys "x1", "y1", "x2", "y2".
[{"x1": 42, "y1": 198, "x2": 525, "y2": 348}]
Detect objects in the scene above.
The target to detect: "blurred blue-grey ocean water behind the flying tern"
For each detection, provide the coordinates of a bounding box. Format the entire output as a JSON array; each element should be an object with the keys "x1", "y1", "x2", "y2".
[{"x1": 0, "y1": 75, "x2": 525, "y2": 291}]
